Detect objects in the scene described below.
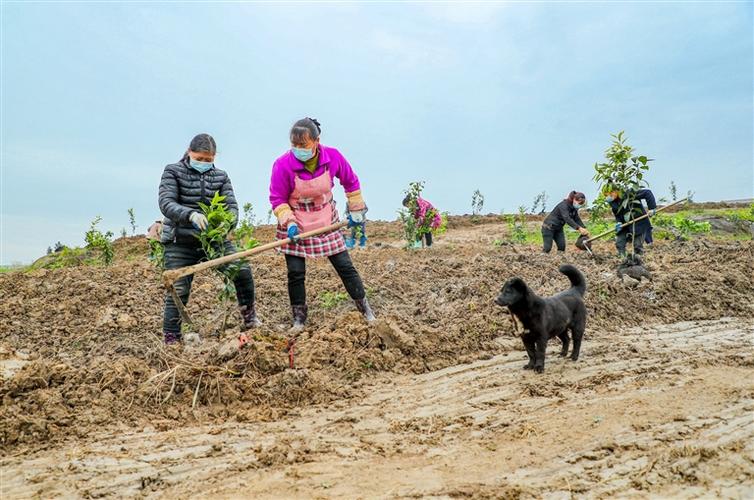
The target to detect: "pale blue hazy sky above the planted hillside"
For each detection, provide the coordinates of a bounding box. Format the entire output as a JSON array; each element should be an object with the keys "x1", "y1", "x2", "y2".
[{"x1": 0, "y1": 1, "x2": 754, "y2": 265}]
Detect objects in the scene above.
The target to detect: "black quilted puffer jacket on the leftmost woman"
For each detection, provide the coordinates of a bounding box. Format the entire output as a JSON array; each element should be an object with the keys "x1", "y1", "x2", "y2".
[{"x1": 159, "y1": 157, "x2": 238, "y2": 244}]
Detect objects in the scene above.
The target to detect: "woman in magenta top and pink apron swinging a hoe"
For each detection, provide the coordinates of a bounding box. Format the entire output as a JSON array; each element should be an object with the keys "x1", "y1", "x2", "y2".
[{"x1": 270, "y1": 118, "x2": 375, "y2": 330}]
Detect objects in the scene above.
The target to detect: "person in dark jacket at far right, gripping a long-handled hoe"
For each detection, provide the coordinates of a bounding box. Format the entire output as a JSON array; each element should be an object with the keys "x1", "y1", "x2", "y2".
[{"x1": 603, "y1": 186, "x2": 657, "y2": 257}]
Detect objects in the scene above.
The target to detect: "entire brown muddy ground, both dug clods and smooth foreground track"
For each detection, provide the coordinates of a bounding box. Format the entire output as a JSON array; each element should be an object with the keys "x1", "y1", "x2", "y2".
[{"x1": 0, "y1": 218, "x2": 754, "y2": 498}]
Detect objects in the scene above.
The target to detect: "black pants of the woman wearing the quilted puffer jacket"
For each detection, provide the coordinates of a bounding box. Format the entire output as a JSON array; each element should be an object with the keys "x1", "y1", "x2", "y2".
[{"x1": 162, "y1": 241, "x2": 254, "y2": 333}]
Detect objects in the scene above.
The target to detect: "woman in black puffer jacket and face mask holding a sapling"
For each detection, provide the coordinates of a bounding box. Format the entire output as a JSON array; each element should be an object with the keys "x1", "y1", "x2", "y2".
[{"x1": 159, "y1": 134, "x2": 261, "y2": 344}]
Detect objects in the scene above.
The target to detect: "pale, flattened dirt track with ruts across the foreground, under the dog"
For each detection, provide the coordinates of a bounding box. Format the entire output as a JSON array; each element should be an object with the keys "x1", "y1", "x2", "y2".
[{"x1": 0, "y1": 318, "x2": 754, "y2": 498}]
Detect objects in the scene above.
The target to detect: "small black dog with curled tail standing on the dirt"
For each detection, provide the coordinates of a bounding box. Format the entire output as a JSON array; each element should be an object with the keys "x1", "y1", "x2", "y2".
[{"x1": 495, "y1": 264, "x2": 586, "y2": 373}]
